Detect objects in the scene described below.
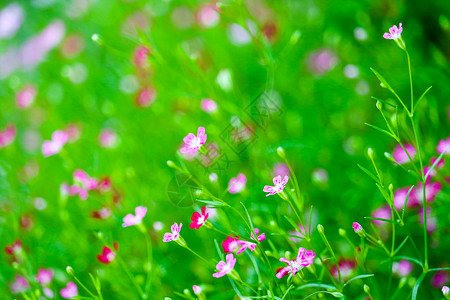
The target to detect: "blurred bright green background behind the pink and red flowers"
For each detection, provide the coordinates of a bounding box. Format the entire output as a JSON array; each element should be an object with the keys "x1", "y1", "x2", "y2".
[{"x1": 0, "y1": 0, "x2": 450, "y2": 299}]
